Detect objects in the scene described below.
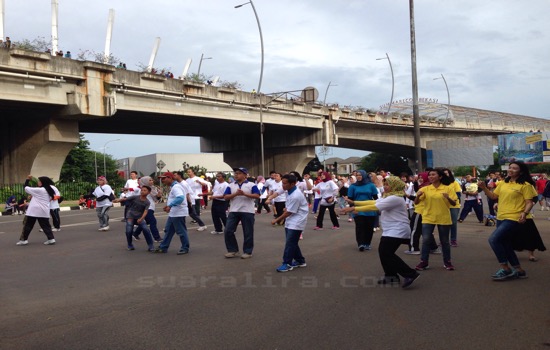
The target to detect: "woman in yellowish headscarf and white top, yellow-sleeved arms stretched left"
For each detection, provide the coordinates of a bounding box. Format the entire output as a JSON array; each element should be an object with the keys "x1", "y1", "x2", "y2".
[{"x1": 343, "y1": 176, "x2": 420, "y2": 288}]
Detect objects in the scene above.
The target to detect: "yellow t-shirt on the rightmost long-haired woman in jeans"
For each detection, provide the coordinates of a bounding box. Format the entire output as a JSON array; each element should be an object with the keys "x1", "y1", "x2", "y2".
[{"x1": 494, "y1": 181, "x2": 537, "y2": 221}]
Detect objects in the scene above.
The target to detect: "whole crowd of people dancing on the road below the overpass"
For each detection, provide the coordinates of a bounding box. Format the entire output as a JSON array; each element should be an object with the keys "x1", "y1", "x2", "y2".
[{"x1": 9, "y1": 162, "x2": 550, "y2": 288}]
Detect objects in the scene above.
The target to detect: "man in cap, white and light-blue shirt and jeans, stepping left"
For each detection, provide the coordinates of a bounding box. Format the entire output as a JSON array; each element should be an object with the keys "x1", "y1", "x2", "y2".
[{"x1": 155, "y1": 171, "x2": 189, "y2": 255}]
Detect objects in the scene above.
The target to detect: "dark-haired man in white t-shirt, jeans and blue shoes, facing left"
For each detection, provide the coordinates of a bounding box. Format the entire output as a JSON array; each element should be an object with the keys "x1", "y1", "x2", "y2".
[{"x1": 271, "y1": 174, "x2": 309, "y2": 272}]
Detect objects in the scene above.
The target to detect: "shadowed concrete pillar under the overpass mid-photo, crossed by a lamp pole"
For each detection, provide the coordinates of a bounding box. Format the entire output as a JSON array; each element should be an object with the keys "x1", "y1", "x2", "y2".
[{"x1": 223, "y1": 146, "x2": 315, "y2": 176}]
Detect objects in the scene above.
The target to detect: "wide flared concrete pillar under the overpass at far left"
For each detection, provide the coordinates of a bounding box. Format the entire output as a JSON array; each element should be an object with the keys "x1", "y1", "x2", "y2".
[{"x1": 0, "y1": 115, "x2": 79, "y2": 183}]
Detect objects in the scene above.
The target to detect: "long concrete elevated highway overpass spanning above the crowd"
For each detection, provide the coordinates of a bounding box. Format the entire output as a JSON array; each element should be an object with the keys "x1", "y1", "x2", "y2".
[{"x1": 0, "y1": 49, "x2": 550, "y2": 182}]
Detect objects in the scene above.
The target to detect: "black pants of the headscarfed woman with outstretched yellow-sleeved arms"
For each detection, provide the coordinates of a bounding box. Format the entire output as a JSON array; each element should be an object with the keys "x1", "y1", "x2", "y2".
[{"x1": 378, "y1": 236, "x2": 417, "y2": 277}]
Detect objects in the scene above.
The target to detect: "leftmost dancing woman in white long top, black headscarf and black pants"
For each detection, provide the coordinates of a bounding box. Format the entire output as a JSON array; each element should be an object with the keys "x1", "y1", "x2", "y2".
[{"x1": 16, "y1": 175, "x2": 59, "y2": 245}]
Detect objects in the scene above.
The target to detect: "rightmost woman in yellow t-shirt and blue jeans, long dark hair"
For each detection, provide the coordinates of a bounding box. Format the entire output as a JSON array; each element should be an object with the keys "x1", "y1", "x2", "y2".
[{"x1": 484, "y1": 162, "x2": 537, "y2": 281}]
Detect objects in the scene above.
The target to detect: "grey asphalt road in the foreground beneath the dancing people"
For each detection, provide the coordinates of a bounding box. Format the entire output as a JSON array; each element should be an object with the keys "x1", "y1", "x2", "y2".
[{"x1": 0, "y1": 204, "x2": 550, "y2": 349}]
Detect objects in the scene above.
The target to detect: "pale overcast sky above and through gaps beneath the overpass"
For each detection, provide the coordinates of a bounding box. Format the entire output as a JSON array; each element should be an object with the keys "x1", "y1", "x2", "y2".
[{"x1": 4, "y1": 0, "x2": 550, "y2": 158}]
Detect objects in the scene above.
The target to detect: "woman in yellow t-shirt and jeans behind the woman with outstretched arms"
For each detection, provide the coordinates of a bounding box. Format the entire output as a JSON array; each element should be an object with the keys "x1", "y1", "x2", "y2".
[{"x1": 414, "y1": 169, "x2": 458, "y2": 271}]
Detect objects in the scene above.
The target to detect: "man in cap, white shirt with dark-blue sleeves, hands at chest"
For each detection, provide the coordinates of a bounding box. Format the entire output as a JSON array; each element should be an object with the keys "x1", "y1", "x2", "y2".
[{"x1": 224, "y1": 168, "x2": 260, "y2": 259}]
